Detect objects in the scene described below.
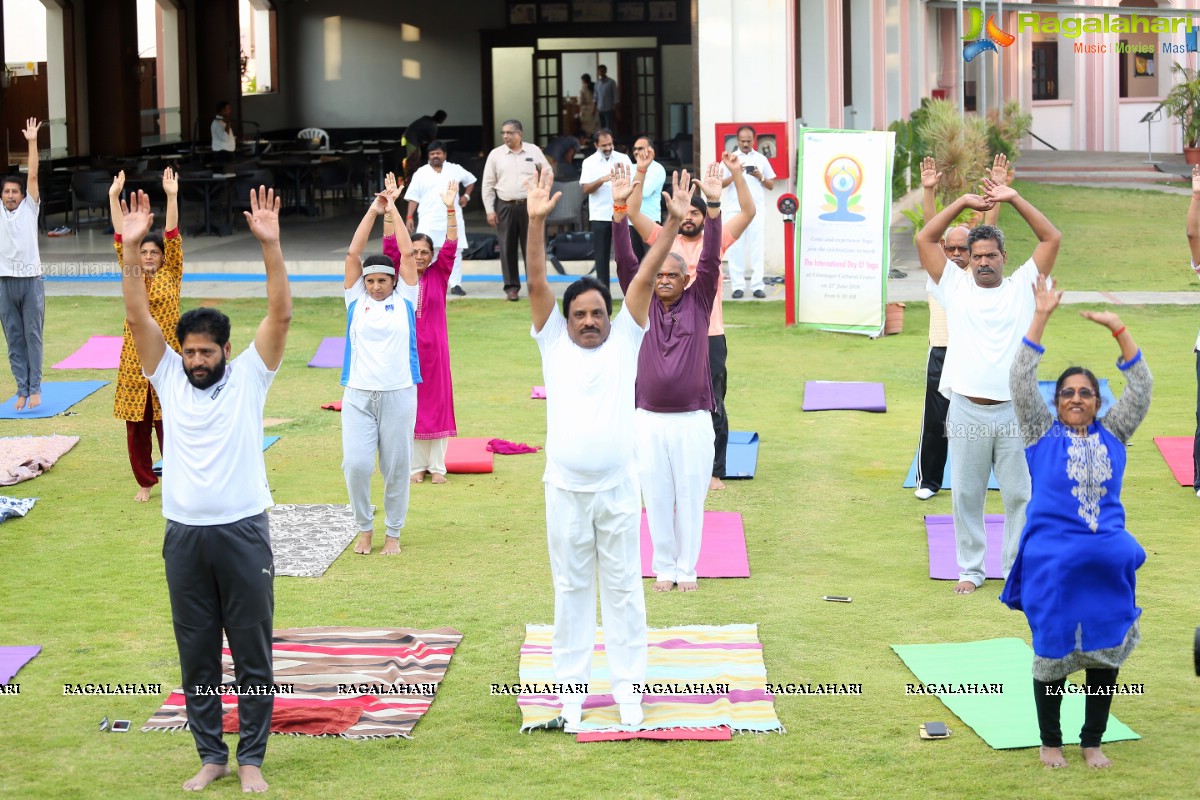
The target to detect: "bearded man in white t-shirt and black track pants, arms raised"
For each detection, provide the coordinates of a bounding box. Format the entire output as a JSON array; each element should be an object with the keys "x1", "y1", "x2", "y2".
[{"x1": 121, "y1": 188, "x2": 292, "y2": 792}]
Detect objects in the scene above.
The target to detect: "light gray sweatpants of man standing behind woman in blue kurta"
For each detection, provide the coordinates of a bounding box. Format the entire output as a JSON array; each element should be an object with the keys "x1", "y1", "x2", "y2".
[{"x1": 946, "y1": 393, "x2": 1031, "y2": 587}]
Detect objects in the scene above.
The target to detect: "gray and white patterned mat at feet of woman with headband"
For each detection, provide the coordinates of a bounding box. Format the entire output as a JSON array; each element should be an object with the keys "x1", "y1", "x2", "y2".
[{"x1": 270, "y1": 503, "x2": 358, "y2": 578}]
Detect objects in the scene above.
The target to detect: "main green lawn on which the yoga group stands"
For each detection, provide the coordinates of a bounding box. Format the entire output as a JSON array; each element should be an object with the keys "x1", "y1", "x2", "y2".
[{"x1": 0, "y1": 297, "x2": 1200, "y2": 800}]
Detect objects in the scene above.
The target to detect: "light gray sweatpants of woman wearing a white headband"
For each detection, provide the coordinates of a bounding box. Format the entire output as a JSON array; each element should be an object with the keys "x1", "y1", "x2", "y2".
[{"x1": 342, "y1": 386, "x2": 416, "y2": 539}]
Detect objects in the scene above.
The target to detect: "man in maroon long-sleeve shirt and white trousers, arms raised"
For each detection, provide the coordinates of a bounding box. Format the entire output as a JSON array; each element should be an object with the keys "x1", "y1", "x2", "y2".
[{"x1": 612, "y1": 164, "x2": 722, "y2": 591}]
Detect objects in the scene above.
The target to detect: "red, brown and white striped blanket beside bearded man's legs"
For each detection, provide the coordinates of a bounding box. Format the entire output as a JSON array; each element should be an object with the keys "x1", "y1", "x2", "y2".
[{"x1": 142, "y1": 627, "x2": 462, "y2": 739}]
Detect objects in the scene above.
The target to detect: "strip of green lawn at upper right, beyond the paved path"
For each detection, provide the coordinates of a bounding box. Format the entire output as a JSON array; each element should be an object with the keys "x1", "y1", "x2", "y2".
[{"x1": 955, "y1": 181, "x2": 1200, "y2": 291}]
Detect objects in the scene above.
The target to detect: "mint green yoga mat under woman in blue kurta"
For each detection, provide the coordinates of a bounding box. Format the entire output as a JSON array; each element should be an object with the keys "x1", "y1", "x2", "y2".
[{"x1": 892, "y1": 639, "x2": 1141, "y2": 750}]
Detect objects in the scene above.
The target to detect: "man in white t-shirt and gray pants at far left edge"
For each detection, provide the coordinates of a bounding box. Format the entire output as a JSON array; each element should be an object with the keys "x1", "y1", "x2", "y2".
[{"x1": 0, "y1": 116, "x2": 46, "y2": 411}]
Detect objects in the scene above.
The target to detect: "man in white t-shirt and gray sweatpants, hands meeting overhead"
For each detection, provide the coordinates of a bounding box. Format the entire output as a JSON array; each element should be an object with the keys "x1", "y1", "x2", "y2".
[{"x1": 917, "y1": 178, "x2": 1062, "y2": 595}]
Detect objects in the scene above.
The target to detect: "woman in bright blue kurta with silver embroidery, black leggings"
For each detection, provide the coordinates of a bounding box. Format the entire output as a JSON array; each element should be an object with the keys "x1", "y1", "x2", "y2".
[{"x1": 1000, "y1": 277, "x2": 1152, "y2": 766}]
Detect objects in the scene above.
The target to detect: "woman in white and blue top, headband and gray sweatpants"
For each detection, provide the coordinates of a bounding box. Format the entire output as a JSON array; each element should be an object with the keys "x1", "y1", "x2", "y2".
[{"x1": 342, "y1": 187, "x2": 421, "y2": 555}]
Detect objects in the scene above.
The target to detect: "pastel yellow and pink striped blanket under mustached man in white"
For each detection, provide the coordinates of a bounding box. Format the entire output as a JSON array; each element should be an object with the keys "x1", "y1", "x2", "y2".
[{"x1": 517, "y1": 625, "x2": 784, "y2": 733}]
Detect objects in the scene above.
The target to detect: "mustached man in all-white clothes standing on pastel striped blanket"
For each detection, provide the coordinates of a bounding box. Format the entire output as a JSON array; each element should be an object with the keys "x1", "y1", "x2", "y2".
[{"x1": 526, "y1": 165, "x2": 691, "y2": 727}]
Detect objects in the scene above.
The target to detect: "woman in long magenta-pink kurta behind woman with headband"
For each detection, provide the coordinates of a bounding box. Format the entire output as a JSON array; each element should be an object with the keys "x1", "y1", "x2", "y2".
[{"x1": 383, "y1": 175, "x2": 458, "y2": 483}]
